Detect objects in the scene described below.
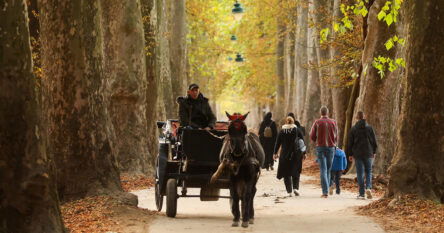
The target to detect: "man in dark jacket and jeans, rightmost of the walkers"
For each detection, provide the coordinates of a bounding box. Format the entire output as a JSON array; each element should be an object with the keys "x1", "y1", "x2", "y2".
[{"x1": 347, "y1": 111, "x2": 378, "y2": 199}]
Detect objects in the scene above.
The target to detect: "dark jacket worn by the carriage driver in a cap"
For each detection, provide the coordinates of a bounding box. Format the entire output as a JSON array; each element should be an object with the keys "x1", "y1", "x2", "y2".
[{"x1": 177, "y1": 94, "x2": 216, "y2": 128}]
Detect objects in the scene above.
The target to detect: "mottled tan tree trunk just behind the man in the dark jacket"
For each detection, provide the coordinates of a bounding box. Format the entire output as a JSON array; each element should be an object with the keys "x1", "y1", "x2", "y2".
[{"x1": 353, "y1": 0, "x2": 401, "y2": 173}]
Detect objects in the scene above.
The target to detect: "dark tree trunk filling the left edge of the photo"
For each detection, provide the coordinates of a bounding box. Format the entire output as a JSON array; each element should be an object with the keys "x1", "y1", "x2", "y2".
[{"x1": 0, "y1": 0, "x2": 64, "y2": 233}]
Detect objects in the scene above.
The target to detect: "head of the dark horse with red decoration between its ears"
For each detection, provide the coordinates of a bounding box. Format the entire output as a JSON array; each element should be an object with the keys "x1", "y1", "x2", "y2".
[{"x1": 225, "y1": 112, "x2": 249, "y2": 157}]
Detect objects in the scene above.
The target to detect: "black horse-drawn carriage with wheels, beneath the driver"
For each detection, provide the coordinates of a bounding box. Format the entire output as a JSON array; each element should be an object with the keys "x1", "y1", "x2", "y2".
[{"x1": 155, "y1": 120, "x2": 229, "y2": 217}]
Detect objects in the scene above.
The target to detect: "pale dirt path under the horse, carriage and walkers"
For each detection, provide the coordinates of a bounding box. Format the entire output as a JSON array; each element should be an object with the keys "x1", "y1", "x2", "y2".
[{"x1": 134, "y1": 171, "x2": 384, "y2": 233}]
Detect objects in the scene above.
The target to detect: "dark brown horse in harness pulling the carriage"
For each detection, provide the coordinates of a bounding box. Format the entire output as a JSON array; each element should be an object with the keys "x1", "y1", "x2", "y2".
[{"x1": 211, "y1": 113, "x2": 265, "y2": 227}]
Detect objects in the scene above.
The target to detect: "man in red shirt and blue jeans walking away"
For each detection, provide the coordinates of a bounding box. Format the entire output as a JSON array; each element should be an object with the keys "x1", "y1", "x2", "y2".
[{"x1": 310, "y1": 106, "x2": 338, "y2": 198}]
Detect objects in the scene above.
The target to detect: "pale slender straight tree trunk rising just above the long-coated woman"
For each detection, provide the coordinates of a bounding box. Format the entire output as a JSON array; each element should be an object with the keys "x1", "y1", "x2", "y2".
[{"x1": 294, "y1": 1, "x2": 308, "y2": 120}]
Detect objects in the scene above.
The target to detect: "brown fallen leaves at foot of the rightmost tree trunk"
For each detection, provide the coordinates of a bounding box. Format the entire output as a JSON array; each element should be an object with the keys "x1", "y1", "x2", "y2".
[{"x1": 358, "y1": 195, "x2": 444, "y2": 233}]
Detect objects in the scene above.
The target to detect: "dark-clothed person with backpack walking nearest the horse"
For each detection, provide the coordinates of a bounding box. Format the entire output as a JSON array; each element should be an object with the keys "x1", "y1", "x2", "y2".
[{"x1": 259, "y1": 112, "x2": 277, "y2": 171}]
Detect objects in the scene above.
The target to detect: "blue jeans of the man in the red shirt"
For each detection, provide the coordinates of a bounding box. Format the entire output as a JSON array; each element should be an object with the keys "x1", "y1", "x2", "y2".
[{"x1": 316, "y1": 146, "x2": 335, "y2": 195}]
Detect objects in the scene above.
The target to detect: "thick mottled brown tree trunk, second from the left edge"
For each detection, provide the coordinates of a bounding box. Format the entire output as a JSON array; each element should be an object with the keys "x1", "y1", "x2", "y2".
[{"x1": 39, "y1": 0, "x2": 122, "y2": 199}]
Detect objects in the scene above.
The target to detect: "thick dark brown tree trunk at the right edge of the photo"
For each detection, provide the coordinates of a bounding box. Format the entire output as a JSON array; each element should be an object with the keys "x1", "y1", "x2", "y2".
[{"x1": 389, "y1": 0, "x2": 444, "y2": 203}]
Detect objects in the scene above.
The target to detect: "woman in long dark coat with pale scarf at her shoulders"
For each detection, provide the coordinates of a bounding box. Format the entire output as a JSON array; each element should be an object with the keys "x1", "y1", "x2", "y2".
[{"x1": 274, "y1": 117, "x2": 303, "y2": 196}]
